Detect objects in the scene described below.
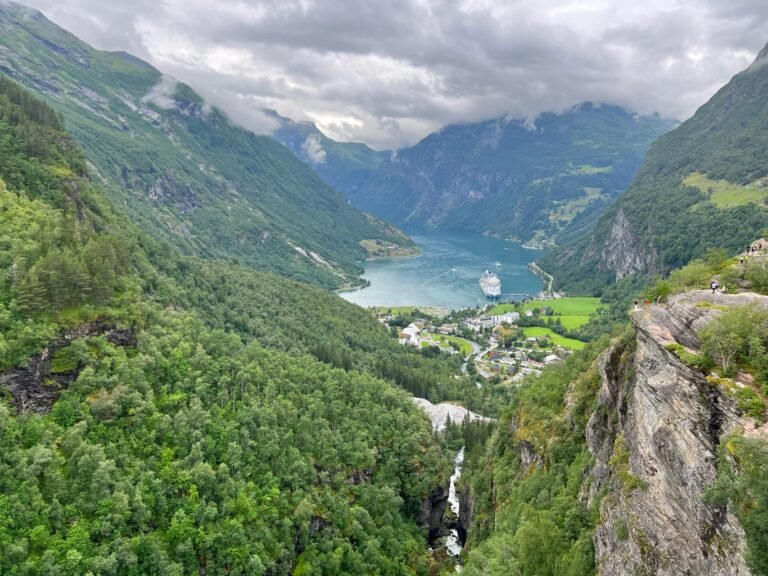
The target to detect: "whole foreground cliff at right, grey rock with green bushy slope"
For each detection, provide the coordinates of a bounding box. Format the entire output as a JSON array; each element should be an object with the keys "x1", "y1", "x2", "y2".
[{"x1": 463, "y1": 291, "x2": 768, "y2": 576}]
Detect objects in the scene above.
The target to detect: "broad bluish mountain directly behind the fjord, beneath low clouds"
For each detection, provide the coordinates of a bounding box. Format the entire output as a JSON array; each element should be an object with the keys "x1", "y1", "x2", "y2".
[{"x1": 348, "y1": 103, "x2": 674, "y2": 241}]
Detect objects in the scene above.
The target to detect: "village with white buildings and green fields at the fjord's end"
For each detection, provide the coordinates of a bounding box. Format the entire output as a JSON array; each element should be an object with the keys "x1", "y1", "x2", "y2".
[{"x1": 374, "y1": 298, "x2": 601, "y2": 386}]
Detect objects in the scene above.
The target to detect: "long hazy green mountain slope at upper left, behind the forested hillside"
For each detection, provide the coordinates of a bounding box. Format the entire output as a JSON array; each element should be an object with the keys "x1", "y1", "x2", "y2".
[{"x1": 0, "y1": 3, "x2": 410, "y2": 287}]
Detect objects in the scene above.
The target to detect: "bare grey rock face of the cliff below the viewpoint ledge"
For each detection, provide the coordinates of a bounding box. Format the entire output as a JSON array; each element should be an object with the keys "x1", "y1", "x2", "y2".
[{"x1": 587, "y1": 291, "x2": 752, "y2": 576}]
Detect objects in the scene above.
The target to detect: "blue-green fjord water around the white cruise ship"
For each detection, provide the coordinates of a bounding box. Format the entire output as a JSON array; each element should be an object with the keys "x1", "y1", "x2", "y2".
[{"x1": 341, "y1": 229, "x2": 542, "y2": 308}]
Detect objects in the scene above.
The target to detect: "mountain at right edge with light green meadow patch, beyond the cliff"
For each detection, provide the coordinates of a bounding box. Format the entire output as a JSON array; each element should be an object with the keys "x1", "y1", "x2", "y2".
[{"x1": 540, "y1": 42, "x2": 768, "y2": 292}]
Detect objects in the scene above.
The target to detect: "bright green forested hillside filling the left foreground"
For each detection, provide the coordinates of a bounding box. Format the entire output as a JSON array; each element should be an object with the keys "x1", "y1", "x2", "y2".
[{"x1": 0, "y1": 73, "x2": 474, "y2": 575}]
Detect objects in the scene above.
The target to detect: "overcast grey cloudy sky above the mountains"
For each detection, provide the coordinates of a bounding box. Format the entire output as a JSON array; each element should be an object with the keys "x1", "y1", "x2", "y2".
[{"x1": 22, "y1": 0, "x2": 768, "y2": 149}]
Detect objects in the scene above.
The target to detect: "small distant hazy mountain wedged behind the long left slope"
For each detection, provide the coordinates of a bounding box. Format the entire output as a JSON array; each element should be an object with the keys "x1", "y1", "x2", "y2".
[{"x1": 265, "y1": 110, "x2": 392, "y2": 196}]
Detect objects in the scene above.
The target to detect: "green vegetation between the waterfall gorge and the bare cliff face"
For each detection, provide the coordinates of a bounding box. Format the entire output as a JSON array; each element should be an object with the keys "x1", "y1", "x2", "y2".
[{"x1": 463, "y1": 338, "x2": 616, "y2": 576}]
